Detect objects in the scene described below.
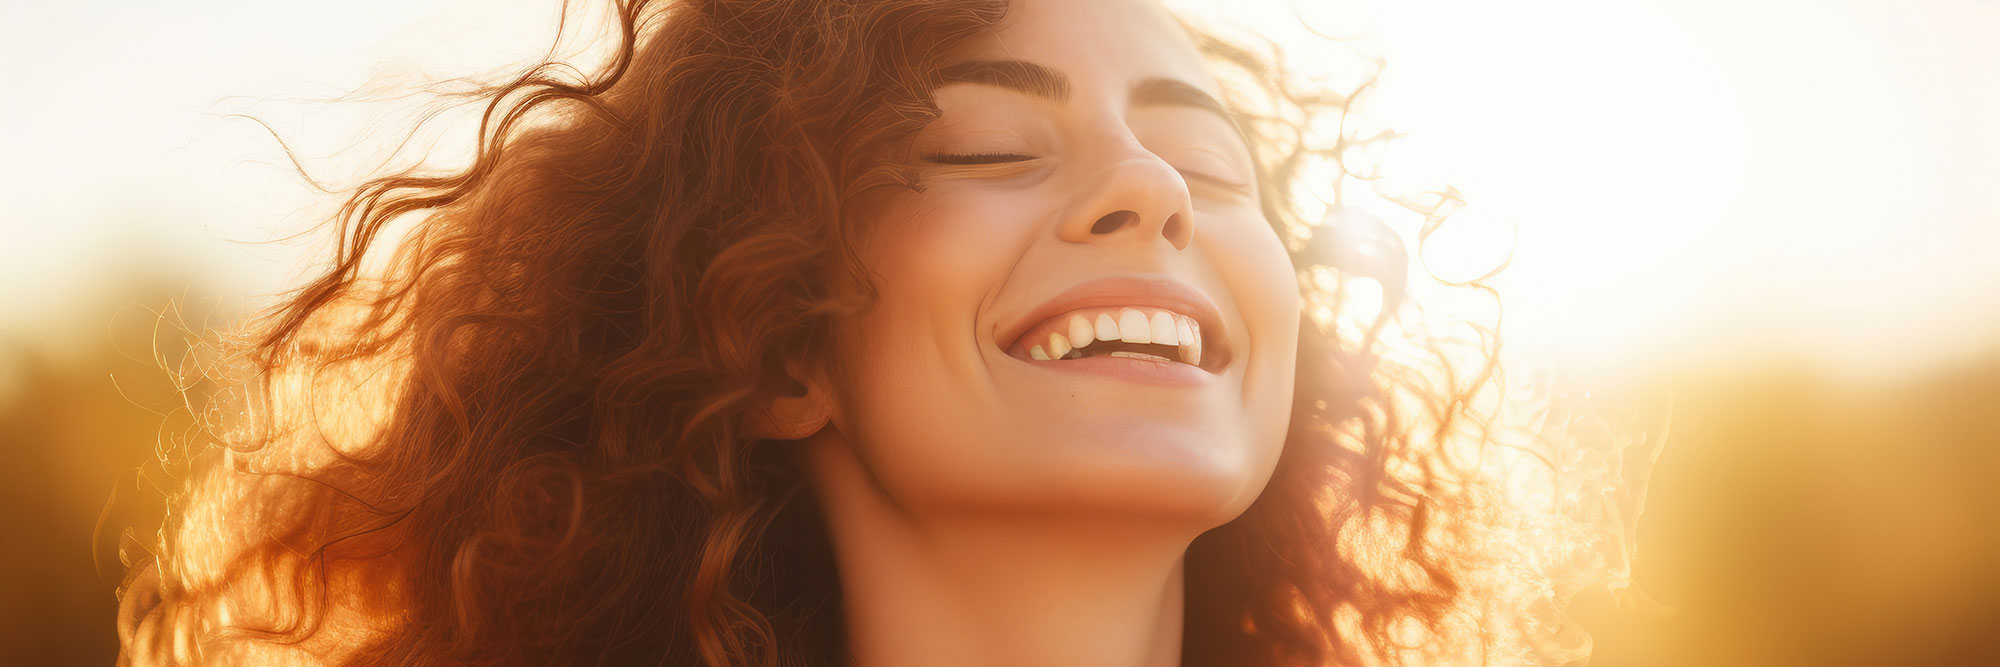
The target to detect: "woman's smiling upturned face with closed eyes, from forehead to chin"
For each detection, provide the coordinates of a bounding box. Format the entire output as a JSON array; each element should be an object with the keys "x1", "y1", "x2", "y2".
[{"x1": 828, "y1": 0, "x2": 1300, "y2": 527}]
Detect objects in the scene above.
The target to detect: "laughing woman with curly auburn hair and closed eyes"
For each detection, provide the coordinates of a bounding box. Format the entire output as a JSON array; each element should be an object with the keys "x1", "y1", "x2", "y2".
[{"x1": 120, "y1": 0, "x2": 1592, "y2": 667}]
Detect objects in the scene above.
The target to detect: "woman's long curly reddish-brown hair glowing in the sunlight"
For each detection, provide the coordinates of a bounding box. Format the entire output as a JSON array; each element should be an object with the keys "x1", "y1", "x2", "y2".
[{"x1": 122, "y1": 0, "x2": 1624, "y2": 667}]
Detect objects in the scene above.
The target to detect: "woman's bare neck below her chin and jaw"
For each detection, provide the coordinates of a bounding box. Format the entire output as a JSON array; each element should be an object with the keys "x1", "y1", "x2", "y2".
[{"x1": 808, "y1": 435, "x2": 1194, "y2": 667}]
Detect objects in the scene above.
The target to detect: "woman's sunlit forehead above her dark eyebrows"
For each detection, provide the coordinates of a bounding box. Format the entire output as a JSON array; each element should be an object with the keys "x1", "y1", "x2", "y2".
[{"x1": 964, "y1": 0, "x2": 1218, "y2": 96}]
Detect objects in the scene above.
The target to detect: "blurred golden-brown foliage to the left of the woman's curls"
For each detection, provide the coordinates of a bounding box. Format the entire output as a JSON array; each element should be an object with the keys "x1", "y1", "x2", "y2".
[{"x1": 0, "y1": 262, "x2": 220, "y2": 665}]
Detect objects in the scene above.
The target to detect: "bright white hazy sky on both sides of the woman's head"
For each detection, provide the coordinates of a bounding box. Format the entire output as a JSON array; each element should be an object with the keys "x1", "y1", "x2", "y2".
[{"x1": 0, "y1": 0, "x2": 2000, "y2": 379}]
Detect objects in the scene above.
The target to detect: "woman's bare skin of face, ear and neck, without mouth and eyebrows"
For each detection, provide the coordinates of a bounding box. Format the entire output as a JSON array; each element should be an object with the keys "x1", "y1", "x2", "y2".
[{"x1": 762, "y1": 0, "x2": 1300, "y2": 667}]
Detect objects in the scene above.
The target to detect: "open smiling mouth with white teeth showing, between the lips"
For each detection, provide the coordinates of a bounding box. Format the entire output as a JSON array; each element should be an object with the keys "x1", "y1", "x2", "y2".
[{"x1": 1008, "y1": 306, "x2": 1224, "y2": 373}]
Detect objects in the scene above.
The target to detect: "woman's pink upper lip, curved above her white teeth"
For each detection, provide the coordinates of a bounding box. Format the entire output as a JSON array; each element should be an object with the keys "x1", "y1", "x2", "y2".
[{"x1": 994, "y1": 276, "x2": 1230, "y2": 367}]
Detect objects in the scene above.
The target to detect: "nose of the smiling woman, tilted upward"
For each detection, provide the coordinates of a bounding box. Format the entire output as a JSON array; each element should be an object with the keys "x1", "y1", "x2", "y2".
[{"x1": 1056, "y1": 150, "x2": 1194, "y2": 250}]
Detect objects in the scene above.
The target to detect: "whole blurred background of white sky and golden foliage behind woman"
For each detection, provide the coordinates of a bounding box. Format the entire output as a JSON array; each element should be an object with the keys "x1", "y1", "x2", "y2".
[{"x1": 0, "y1": 0, "x2": 2000, "y2": 665}]
